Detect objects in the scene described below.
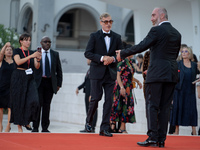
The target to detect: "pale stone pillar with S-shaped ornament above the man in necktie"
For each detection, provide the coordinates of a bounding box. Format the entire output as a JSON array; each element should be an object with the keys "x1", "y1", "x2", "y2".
[{"x1": 31, "y1": 0, "x2": 56, "y2": 49}]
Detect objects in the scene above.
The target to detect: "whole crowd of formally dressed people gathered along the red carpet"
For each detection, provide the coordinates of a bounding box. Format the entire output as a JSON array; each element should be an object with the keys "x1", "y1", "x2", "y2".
[{"x1": 0, "y1": 7, "x2": 200, "y2": 147}]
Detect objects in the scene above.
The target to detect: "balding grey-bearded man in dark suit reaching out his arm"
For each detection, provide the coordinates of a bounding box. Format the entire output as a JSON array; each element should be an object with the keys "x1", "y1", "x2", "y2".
[{"x1": 116, "y1": 8, "x2": 181, "y2": 147}]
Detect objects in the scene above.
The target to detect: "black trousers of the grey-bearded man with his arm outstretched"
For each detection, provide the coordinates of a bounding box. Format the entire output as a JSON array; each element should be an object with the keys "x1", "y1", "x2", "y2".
[{"x1": 145, "y1": 82, "x2": 175, "y2": 142}]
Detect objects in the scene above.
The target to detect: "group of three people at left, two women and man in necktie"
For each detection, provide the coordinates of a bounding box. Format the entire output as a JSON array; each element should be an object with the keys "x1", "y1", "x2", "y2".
[{"x1": 0, "y1": 33, "x2": 62, "y2": 132}]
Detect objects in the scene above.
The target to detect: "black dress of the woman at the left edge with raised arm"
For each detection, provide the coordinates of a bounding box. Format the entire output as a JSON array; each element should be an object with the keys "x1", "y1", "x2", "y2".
[{"x1": 0, "y1": 59, "x2": 14, "y2": 108}]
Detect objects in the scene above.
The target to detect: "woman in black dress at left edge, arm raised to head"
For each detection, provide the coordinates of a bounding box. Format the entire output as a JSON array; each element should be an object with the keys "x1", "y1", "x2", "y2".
[{"x1": 0, "y1": 42, "x2": 14, "y2": 132}]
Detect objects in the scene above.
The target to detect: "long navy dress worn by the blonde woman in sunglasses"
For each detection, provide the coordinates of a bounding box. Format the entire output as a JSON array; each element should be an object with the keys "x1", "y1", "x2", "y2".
[{"x1": 171, "y1": 65, "x2": 197, "y2": 126}]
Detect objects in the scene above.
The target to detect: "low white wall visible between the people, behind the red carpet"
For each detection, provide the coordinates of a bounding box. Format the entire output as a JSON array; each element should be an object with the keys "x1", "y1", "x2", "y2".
[{"x1": 50, "y1": 73, "x2": 200, "y2": 135}]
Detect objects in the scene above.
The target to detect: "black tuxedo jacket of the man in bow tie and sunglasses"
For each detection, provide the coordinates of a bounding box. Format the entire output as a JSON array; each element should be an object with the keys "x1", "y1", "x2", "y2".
[{"x1": 85, "y1": 30, "x2": 122, "y2": 80}]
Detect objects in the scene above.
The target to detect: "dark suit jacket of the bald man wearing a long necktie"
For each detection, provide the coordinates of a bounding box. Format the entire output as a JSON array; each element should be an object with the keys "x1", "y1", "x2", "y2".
[{"x1": 34, "y1": 49, "x2": 63, "y2": 94}]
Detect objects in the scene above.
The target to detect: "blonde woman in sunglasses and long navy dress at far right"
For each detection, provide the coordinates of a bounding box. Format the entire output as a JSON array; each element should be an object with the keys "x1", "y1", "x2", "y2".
[{"x1": 170, "y1": 47, "x2": 199, "y2": 135}]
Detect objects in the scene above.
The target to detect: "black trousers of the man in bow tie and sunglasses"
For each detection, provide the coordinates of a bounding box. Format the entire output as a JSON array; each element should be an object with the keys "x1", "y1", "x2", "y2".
[{"x1": 86, "y1": 70, "x2": 115, "y2": 131}]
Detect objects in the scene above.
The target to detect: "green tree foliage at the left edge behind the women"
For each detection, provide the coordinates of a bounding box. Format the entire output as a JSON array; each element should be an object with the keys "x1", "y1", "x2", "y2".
[{"x1": 0, "y1": 24, "x2": 20, "y2": 48}]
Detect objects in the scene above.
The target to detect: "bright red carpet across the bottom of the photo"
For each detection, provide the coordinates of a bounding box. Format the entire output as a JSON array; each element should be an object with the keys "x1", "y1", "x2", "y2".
[{"x1": 0, "y1": 133, "x2": 200, "y2": 150}]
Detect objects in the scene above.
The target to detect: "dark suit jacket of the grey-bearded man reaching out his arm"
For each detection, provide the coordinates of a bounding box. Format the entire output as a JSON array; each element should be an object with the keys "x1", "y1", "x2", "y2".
[{"x1": 120, "y1": 22, "x2": 181, "y2": 83}]
